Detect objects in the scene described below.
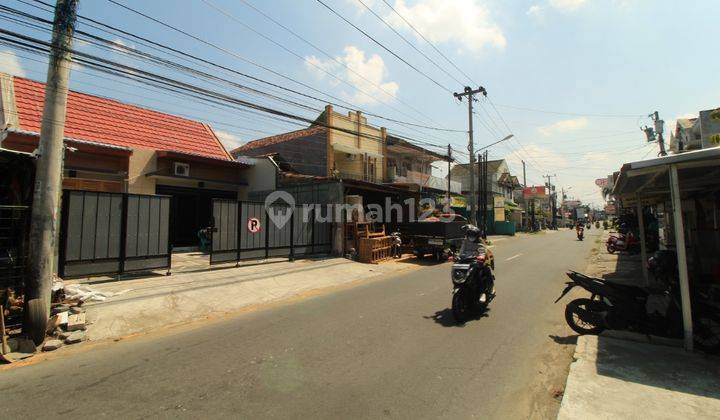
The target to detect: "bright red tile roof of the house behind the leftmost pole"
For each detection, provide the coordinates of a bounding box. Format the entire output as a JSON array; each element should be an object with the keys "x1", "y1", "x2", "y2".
[{"x1": 9, "y1": 77, "x2": 232, "y2": 160}]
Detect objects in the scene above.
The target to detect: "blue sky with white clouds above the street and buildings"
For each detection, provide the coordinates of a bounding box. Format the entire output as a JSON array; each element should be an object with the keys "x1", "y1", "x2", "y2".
[{"x1": 0, "y1": 0, "x2": 720, "y2": 205}]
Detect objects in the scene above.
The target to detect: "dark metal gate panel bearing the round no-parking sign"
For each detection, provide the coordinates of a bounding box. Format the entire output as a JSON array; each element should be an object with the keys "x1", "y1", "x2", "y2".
[{"x1": 210, "y1": 199, "x2": 332, "y2": 264}]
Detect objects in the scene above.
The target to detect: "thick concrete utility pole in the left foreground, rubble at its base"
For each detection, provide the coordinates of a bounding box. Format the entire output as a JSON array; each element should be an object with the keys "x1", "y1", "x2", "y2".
[{"x1": 23, "y1": 0, "x2": 79, "y2": 344}]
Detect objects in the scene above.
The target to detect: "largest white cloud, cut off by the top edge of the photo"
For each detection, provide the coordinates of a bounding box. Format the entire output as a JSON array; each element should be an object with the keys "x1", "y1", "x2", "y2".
[{"x1": 385, "y1": 0, "x2": 507, "y2": 51}]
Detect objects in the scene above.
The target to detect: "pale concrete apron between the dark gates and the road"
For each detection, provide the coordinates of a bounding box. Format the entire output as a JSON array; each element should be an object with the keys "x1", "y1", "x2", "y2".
[{"x1": 71, "y1": 258, "x2": 422, "y2": 341}]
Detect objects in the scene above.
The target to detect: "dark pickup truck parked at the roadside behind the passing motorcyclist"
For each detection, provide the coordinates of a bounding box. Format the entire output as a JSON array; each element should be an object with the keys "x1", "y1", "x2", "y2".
[{"x1": 397, "y1": 215, "x2": 468, "y2": 261}]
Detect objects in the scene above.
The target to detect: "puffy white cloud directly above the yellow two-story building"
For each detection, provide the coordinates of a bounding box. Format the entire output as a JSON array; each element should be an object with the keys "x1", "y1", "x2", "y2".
[{"x1": 305, "y1": 45, "x2": 400, "y2": 105}]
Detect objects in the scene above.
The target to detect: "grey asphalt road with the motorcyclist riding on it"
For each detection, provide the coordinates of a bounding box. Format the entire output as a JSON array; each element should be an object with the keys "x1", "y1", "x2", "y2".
[{"x1": 0, "y1": 229, "x2": 599, "y2": 419}]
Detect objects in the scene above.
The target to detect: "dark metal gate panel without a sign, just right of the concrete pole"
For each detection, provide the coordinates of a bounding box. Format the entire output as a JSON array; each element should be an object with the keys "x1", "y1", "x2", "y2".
[{"x1": 58, "y1": 190, "x2": 171, "y2": 278}]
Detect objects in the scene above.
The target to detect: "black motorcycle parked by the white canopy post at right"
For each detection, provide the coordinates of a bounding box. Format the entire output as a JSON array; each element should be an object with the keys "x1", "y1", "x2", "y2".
[{"x1": 555, "y1": 271, "x2": 720, "y2": 353}]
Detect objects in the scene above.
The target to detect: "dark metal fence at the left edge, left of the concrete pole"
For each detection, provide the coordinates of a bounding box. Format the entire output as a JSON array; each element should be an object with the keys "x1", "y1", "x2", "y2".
[{"x1": 0, "y1": 206, "x2": 30, "y2": 287}]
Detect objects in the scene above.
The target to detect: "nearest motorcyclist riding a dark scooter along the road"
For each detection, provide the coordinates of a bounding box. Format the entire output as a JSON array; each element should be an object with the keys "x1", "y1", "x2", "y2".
[{"x1": 450, "y1": 225, "x2": 495, "y2": 323}]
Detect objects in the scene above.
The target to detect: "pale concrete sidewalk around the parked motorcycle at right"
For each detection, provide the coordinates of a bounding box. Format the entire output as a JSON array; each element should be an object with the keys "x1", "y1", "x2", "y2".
[{"x1": 558, "y1": 232, "x2": 720, "y2": 420}]
